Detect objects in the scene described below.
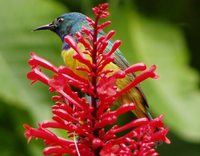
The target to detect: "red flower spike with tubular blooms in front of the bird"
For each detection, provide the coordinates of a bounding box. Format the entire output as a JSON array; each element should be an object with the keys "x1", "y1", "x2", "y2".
[{"x1": 24, "y1": 3, "x2": 170, "y2": 156}]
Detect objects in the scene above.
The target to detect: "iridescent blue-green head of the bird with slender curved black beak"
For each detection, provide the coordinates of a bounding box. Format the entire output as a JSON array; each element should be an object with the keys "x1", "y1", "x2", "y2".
[{"x1": 34, "y1": 12, "x2": 87, "y2": 41}]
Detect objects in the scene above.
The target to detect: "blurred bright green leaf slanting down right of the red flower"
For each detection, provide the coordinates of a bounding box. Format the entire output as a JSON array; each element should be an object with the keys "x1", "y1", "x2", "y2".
[{"x1": 111, "y1": 4, "x2": 200, "y2": 142}]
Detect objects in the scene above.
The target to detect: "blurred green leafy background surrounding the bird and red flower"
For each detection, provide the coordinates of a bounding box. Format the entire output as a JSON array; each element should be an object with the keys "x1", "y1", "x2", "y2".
[{"x1": 0, "y1": 0, "x2": 200, "y2": 156}]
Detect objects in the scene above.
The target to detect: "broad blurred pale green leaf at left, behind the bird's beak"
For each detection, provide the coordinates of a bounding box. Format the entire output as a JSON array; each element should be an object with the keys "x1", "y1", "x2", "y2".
[{"x1": 0, "y1": 0, "x2": 67, "y2": 121}]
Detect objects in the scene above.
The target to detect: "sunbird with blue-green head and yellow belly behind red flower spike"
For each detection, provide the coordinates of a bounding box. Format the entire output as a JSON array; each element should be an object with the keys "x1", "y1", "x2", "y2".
[{"x1": 34, "y1": 12, "x2": 151, "y2": 119}]
